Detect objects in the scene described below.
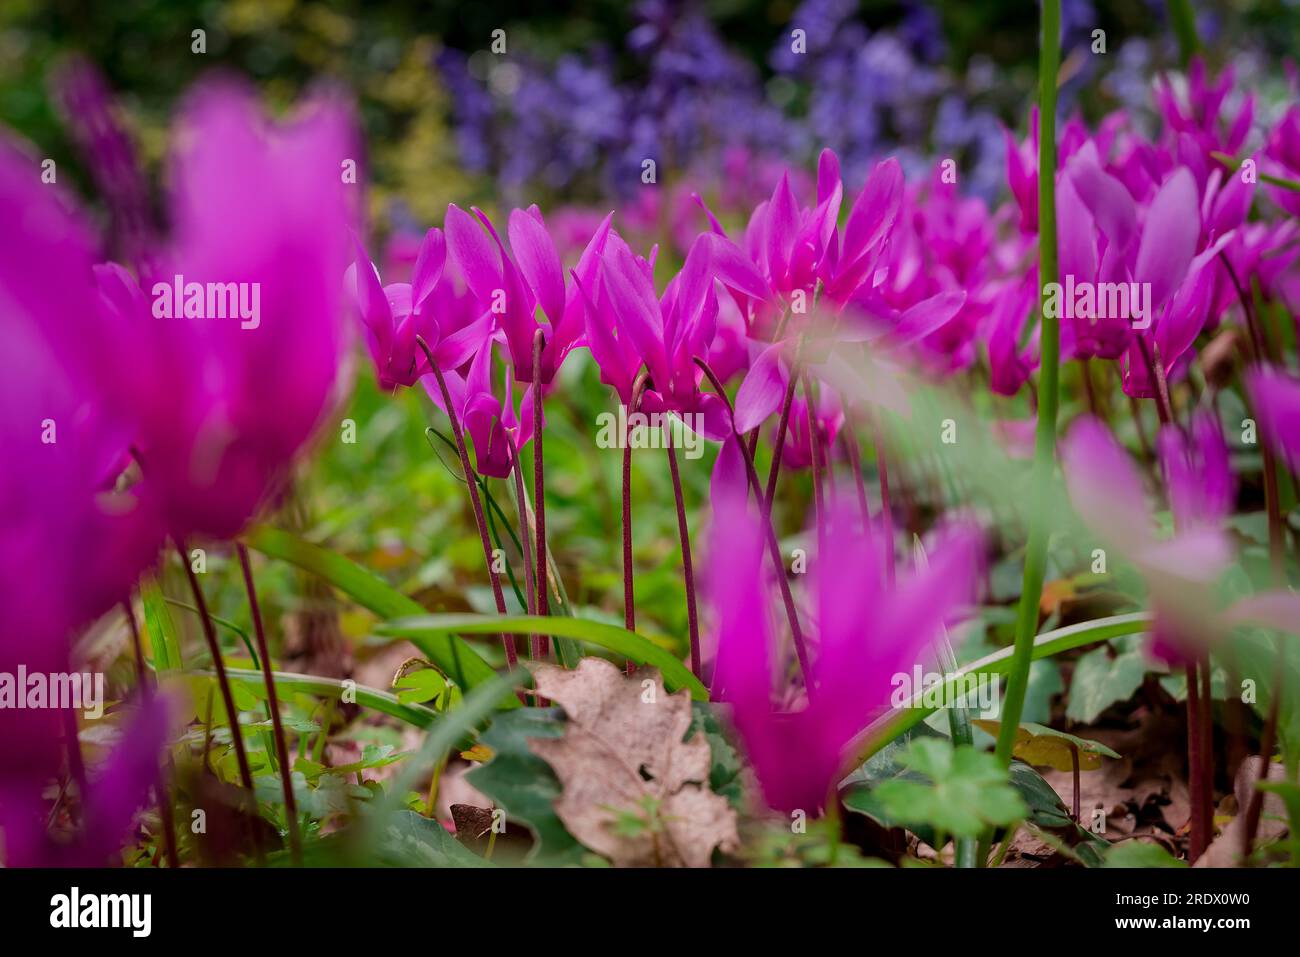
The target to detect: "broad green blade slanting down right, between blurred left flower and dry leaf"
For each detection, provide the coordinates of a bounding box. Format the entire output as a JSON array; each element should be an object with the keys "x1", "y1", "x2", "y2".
[{"x1": 246, "y1": 525, "x2": 520, "y2": 709}]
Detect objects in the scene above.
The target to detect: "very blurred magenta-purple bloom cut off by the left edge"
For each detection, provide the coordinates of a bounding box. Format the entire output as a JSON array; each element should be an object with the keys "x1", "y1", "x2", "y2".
[{"x1": 0, "y1": 139, "x2": 164, "y2": 866}]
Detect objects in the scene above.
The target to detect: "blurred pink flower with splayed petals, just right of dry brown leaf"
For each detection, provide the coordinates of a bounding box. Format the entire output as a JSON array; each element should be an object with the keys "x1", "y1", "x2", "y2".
[{"x1": 710, "y1": 481, "x2": 980, "y2": 814}]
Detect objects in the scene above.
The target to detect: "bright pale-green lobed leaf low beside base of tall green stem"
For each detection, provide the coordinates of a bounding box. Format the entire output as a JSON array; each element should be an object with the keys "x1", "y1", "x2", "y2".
[{"x1": 875, "y1": 737, "x2": 1028, "y2": 837}]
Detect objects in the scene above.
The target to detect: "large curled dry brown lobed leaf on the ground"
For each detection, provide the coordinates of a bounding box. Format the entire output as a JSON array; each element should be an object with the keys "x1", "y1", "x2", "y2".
[{"x1": 529, "y1": 658, "x2": 740, "y2": 867}]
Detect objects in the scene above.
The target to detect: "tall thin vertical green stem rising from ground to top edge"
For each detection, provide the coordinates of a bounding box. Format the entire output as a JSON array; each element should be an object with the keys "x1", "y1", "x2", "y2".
[{"x1": 997, "y1": 0, "x2": 1061, "y2": 767}]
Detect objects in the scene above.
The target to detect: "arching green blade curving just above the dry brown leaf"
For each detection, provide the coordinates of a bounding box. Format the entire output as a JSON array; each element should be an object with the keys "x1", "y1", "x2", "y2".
[{"x1": 376, "y1": 615, "x2": 709, "y2": 701}]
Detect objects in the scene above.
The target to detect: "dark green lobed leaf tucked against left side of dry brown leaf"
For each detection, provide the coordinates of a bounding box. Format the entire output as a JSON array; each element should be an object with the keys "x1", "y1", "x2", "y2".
[{"x1": 465, "y1": 707, "x2": 585, "y2": 865}]
